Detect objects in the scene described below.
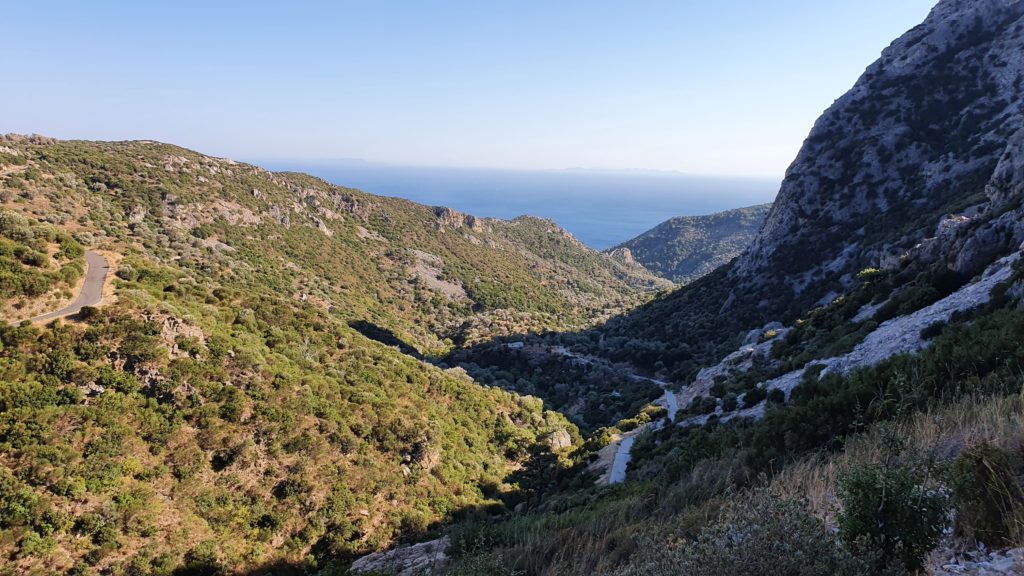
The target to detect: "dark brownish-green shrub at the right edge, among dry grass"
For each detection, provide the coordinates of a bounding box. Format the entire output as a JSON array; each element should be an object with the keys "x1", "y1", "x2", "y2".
[{"x1": 949, "y1": 443, "x2": 1024, "y2": 546}]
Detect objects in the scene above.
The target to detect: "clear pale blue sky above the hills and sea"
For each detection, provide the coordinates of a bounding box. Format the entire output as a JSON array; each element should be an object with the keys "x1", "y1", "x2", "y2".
[{"x1": 0, "y1": 0, "x2": 934, "y2": 177}]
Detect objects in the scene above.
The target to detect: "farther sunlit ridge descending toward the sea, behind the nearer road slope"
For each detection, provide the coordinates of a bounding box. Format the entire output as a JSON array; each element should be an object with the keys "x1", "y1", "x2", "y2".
[{"x1": 0, "y1": 136, "x2": 667, "y2": 353}]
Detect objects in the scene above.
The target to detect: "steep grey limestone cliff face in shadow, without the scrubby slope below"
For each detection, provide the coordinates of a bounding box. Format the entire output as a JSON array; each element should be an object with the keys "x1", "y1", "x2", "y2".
[{"x1": 730, "y1": 0, "x2": 1024, "y2": 296}]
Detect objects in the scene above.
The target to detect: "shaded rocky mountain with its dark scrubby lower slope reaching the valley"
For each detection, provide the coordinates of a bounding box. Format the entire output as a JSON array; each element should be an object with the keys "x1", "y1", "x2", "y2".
[{"x1": 606, "y1": 0, "x2": 1024, "y2": 377}]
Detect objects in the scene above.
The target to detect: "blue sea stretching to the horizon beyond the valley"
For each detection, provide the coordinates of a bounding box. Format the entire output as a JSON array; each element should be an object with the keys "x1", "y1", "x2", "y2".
[{"x1": 262, "y1": 161, "x2": 778, "y2": 250}]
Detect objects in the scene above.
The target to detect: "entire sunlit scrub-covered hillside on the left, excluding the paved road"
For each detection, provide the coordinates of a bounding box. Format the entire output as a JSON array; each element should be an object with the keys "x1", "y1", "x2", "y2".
[{"x1": 0, "y1": 135, "x2": 668, "y2": 574}]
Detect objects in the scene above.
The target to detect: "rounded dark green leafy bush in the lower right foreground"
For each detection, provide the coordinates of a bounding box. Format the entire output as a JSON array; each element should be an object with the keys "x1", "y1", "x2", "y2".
[{"x1": 839, "y1": 464, "x2": 949, "y2": 570}]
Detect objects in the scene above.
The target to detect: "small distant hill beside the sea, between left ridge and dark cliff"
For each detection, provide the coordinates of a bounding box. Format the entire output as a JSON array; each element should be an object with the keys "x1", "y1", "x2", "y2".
[{"x1": 606, "y1": 204, "x2": 771, "y2": 284}]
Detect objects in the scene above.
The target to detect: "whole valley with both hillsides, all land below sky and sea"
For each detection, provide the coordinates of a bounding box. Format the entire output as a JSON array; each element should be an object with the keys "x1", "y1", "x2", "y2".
[{"x1": 0, "y1": 0, "x2": 1024, "y2": 576}]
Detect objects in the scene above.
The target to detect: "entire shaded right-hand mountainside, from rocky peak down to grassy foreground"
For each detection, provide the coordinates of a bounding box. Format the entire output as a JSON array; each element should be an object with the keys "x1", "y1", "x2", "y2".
[{"x1": 438, "y1": 0, "x2": 1024, "y2": 576}]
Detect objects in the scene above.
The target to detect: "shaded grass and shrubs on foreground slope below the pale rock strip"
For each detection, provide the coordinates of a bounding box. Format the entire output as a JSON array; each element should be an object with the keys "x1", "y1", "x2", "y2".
[{"x1": 457, "y1": 272, "x2": 1024, "y2": 576}]
